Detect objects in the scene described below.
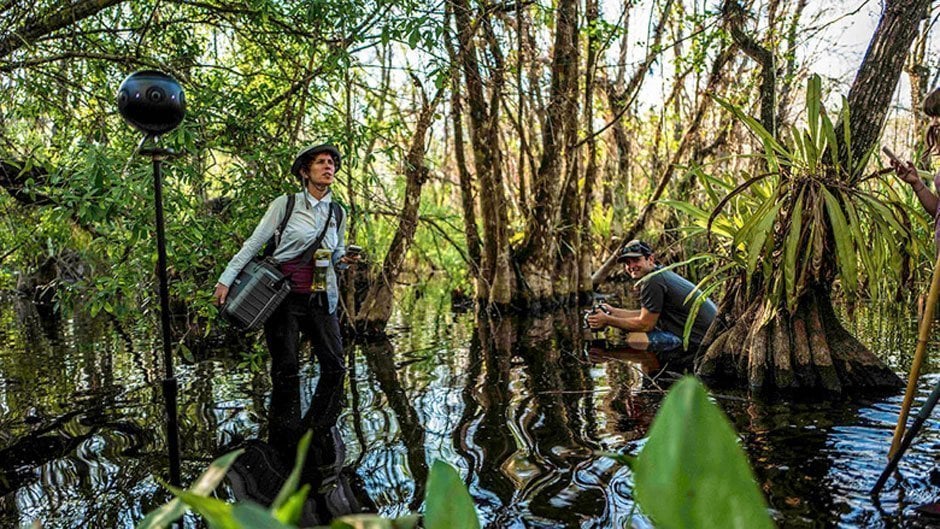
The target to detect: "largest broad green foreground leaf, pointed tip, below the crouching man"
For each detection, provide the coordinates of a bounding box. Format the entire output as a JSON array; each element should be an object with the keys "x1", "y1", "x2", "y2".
[{"x1": 633, "y1": 377, "x2": 773, "y2": 529}]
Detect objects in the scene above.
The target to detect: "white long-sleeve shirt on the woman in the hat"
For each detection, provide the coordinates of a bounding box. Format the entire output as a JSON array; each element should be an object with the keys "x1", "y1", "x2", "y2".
[{"x1": 219, "y1": 189, "x2": 347, "y2": 313}]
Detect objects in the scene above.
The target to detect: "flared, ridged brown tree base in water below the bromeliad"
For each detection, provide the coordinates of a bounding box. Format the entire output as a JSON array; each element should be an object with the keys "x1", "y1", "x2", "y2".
[{"x1": 695, "y1": 289, "x2": 903, "y2": 394}]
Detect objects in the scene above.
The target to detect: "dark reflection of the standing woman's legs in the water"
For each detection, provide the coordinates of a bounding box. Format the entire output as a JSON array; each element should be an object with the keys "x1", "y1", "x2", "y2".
[{"x1": 228, "y1": 372, "x2": 375, "y2": 527}]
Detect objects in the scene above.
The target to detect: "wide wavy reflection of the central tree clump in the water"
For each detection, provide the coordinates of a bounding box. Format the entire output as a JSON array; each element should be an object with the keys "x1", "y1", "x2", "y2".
[{"x1": 454, "y1": 313, "x2": 603, "y2": 525}]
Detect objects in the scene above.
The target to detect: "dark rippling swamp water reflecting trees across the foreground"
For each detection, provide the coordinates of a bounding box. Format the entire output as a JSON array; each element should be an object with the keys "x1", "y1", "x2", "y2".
[{"x1": 0, "y1": 298, "x2": 940, "y2": 528}]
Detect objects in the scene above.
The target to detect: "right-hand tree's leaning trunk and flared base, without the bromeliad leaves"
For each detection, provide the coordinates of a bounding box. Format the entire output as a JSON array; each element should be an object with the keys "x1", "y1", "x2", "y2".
[{"x1": 696, "y1": 0, "x2": 930, "y2": 393}]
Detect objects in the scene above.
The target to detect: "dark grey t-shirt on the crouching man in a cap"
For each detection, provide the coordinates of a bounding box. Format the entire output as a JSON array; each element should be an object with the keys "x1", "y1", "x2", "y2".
[{"x1": 640, "y1": 266, "x2": 718, "y2": 348}]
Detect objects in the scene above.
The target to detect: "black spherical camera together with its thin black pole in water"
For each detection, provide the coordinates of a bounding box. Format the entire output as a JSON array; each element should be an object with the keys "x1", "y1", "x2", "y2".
[{"x1": 117, "y1": 70, "x2": 186, "y2": 487}]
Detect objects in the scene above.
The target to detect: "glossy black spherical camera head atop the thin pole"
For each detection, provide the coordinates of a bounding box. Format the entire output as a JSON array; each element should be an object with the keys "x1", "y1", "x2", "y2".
[{"x1": 118, "y1": 70, "x2": 186, "y2": 136}]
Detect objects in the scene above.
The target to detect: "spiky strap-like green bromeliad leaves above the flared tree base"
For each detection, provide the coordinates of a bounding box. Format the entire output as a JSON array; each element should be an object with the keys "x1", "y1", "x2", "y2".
[{"x1": 667, "y1": 76, "x2": 912, "y2": 312}]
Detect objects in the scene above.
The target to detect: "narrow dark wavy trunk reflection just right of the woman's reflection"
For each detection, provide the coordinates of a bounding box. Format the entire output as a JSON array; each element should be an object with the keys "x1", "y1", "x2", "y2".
[{"x1": 362, "y1": 339, "x2": 428, "y2": 510}]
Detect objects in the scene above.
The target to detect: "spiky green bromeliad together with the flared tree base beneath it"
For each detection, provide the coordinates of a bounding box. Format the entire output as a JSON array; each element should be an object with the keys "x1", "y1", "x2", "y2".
[{"x1": 670, "y1": 76, "x2": 916, "y2": 393}]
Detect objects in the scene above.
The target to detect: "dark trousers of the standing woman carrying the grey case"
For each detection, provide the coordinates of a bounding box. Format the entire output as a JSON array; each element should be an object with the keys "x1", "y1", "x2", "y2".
[{"x1": 264, "y1": 292, "x2": 346, "y2": 381}]
